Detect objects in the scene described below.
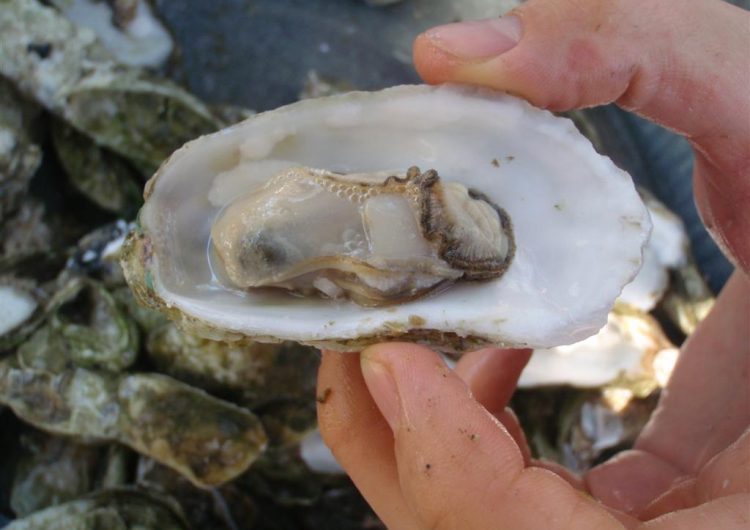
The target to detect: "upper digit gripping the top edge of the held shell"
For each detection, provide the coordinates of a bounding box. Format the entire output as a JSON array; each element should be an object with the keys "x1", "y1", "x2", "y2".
[{"x1": 414, "y1": 0, "x2": 750, "y2": 270}]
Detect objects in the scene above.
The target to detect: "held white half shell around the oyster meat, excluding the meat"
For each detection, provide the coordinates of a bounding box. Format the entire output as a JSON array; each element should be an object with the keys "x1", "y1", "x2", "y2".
[{"x1": 123, "y1": 86, "x2": 651, "y2": 350}]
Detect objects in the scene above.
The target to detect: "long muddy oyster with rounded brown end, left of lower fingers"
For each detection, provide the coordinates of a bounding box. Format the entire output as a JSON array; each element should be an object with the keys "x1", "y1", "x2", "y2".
[{"x1": 0, "y1": 358, "x2": 266, "y2": 487}]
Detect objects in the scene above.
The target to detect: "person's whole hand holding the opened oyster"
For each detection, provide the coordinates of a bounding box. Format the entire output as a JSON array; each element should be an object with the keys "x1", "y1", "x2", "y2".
[{"x1": 318, "y1": 0, "x2": 750, "y2": 530}]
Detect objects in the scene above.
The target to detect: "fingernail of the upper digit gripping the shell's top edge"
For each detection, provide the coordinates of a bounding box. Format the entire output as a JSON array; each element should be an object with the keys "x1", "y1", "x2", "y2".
[{"x1": 425, "y1": 15, "x2": 523, "y2": 59}]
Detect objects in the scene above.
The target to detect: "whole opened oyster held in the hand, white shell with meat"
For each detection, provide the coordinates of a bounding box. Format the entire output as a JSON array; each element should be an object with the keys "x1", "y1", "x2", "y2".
[{"x1": 122, "y1": 86, "x2": 651, "y2": 351}]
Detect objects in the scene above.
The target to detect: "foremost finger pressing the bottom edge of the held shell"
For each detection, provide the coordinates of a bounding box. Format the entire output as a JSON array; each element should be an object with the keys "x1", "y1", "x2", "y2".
[{"x1": 361, "y1": 344, "x2": 622, "y2": 530}]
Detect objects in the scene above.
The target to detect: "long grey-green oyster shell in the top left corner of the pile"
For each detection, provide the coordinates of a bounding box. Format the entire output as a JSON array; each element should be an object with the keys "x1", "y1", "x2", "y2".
[{"x1": 0, "y1": 0, "x2": 221, "y2": 172}]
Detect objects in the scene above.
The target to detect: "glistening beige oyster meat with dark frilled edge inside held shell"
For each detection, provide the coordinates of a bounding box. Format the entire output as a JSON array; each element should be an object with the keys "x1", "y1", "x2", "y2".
[{"x1": 212, "y1": 167, "x2": 513, "y2": 306}]
